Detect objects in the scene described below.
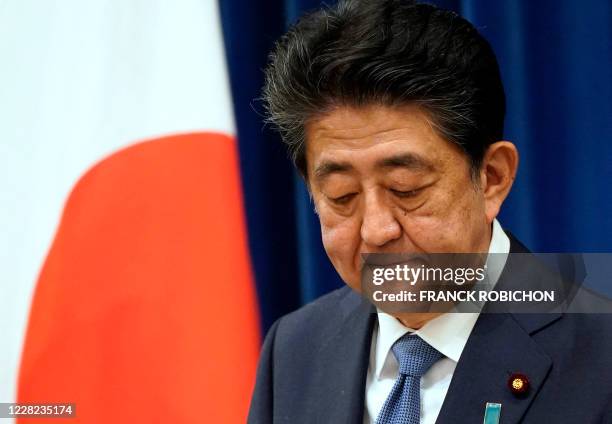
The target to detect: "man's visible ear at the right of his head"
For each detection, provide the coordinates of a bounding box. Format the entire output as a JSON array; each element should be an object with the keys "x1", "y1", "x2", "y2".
[{"x1": 480, "y1": 141, "x2": 519, "y2": 224}]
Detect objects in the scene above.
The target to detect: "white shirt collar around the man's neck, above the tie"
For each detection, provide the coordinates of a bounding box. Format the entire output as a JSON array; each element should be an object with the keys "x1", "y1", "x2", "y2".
[{"x1": 375, "y1": 219, "x2": 510, "y2": 378}]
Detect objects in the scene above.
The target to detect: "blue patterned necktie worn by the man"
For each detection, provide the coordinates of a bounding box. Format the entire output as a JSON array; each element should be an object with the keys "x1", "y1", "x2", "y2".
[{"x1": 376, "y1": 334, "x2": 443, "y2": 424}]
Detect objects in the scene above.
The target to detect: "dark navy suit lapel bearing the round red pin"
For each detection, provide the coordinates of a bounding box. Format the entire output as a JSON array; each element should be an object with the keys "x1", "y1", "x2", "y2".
[{"x1": 436, "y1": 234, "x2": 561, "y2": 424}]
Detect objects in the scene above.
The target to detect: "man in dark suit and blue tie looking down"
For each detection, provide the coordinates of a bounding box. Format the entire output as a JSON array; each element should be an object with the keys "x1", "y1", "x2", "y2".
[{"x1": 249, "y1": 0, "x2": 612, "y2": 423}]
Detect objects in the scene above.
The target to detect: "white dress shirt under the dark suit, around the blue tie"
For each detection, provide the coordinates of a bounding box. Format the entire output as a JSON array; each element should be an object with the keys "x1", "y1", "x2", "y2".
[{"x1": 363, "y1": 220, "x2": 510, "y2": 424}]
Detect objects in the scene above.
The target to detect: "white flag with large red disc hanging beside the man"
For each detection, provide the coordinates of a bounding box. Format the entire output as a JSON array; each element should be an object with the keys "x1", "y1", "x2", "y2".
[{"x1": 0, "y1": 0, "x2": 260, "y2": 423}]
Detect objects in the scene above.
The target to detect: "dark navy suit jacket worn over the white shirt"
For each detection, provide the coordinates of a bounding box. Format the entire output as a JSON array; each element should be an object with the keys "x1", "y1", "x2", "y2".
[{"x1": 248, "y1": 237, "x2": 612, "y2": 424}]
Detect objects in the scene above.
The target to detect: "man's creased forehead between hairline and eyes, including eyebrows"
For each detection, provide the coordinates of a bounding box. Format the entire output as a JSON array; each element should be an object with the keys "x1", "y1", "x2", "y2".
[{"x1": 306, "y1": 105, "x2": 465, "y2": 181}]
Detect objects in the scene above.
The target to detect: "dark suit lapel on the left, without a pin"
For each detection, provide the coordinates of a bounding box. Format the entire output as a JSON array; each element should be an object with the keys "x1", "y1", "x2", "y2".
[{"x1": 312, "y1": 290, "x2": 376, "y2": 424}]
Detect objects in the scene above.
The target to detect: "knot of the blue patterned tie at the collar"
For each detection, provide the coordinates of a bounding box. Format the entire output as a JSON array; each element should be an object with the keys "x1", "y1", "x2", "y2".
[{"x1": 391, "y1": 334, "x2": 443, "y2": 378}]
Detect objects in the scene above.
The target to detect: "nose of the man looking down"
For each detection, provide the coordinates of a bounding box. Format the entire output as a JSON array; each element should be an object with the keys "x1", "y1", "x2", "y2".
[{"x1": 361, "y1": 194, "x2": 402, "y2": 249}]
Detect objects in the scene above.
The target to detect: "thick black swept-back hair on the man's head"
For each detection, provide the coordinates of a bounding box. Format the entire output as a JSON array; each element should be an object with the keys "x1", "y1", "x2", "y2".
[{"x1": 263, "y1": 0, "x2": 505, "y2": 178}]
